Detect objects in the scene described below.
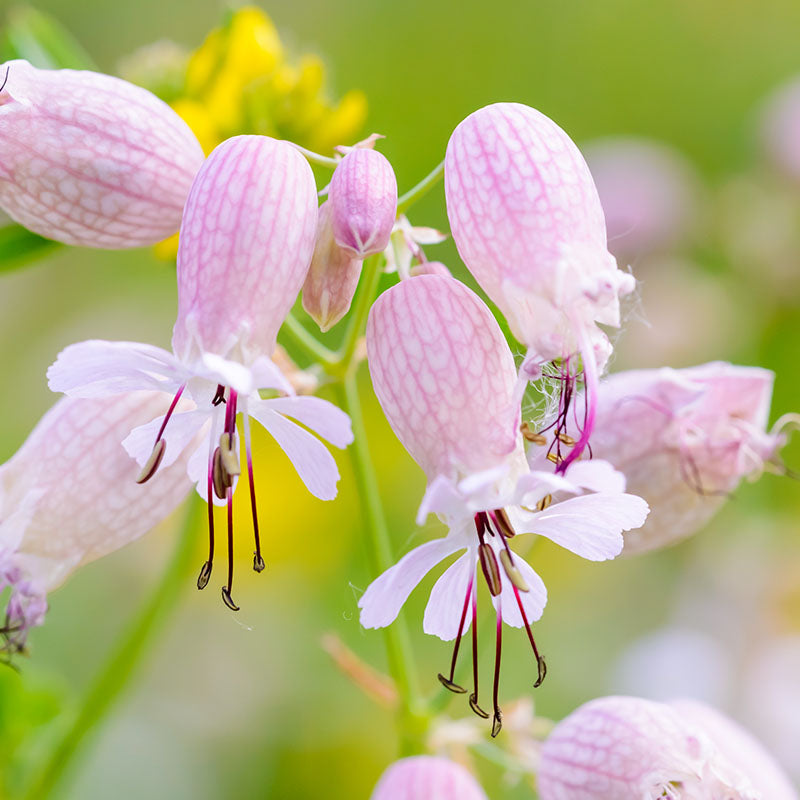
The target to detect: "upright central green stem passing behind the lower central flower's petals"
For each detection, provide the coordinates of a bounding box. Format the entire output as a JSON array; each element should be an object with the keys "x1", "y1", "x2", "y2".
[{"x1": 336, "y1": 372, "x2": 427, "y2": 755}]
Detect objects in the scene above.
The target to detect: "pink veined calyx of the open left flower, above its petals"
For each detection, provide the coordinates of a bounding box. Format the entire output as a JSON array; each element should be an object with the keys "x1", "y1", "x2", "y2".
[{"x1": 173, "y1": 136, "x2": 317, "y2": 365}]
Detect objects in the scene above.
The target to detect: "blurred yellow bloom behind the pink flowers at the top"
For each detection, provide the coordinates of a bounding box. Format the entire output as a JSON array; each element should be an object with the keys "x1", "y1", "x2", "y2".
[{"x1": 134, "y1": 6, "x2": 367, "y2": 258}]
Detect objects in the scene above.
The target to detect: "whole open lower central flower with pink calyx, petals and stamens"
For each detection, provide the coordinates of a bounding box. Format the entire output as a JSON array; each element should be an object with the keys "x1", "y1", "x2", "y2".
[{"x1": 359, "y1": 275, "x2": 647, "y2": 735}]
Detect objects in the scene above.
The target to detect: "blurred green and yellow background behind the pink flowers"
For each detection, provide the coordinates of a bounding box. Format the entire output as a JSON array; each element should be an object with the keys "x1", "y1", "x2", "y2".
[{"x1": 0, "y1": 0, "x2": 800, "y2": 800}]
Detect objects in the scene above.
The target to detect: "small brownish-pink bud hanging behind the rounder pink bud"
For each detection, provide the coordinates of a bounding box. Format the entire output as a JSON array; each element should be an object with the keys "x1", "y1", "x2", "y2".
[{"x1": 303, "y1": 201, "x2": 362, "y2": 332}]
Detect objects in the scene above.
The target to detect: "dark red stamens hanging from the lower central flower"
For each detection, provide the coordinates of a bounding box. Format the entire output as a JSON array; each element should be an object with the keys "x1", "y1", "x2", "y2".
[{"x1": 439, "y1": 508, "x2": 547, "y2": 737}]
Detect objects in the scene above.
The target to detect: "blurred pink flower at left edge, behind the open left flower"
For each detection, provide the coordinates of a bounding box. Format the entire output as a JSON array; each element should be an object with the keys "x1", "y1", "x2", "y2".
[{"x1": 0, "y1": 392, "x2": 191, "y2": 652}]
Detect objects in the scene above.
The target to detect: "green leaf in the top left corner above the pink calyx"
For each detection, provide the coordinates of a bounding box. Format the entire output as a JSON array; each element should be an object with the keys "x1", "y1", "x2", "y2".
[{"x1": 0, "y1": 6, "x2": 97, "y2": 70}]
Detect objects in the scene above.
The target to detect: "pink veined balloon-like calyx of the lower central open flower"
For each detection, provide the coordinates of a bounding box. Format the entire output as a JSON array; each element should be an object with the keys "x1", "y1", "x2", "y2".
[{"x1": 367, "y1": 275, "x2": 521, "y2": 478}]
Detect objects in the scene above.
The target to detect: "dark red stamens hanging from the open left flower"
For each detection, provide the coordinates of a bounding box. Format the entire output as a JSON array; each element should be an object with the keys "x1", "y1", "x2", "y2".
[{"x1": 137, "y1": 385, "x2": 265, "y2": 611}]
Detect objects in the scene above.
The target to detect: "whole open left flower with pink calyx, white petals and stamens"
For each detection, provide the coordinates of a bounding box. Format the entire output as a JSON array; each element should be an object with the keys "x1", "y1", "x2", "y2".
[{"x1": 48, "y1": 136, "x2": 352, "y2": 610}]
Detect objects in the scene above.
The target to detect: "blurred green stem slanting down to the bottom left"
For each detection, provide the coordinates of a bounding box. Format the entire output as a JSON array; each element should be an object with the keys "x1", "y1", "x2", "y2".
[{"x1": 25, "y1": 497, "x2": 205, "y2": 800}]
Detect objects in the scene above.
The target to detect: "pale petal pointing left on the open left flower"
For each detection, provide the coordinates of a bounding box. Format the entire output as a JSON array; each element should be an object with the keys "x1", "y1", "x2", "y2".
[{"x1": 47, "y1": 340, "x2": 183, "y2": 397}]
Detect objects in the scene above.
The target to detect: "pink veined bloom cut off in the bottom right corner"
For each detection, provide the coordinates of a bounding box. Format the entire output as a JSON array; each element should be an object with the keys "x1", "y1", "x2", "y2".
[{"x1": 537, "y1": 697, "x2": 797, "y2": 800}]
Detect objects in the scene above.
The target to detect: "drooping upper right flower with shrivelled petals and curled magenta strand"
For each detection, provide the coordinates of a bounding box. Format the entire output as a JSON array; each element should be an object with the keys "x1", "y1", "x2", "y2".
[{"x1": 445, "y1": 103, "x2": 634, "y2": 472}]
